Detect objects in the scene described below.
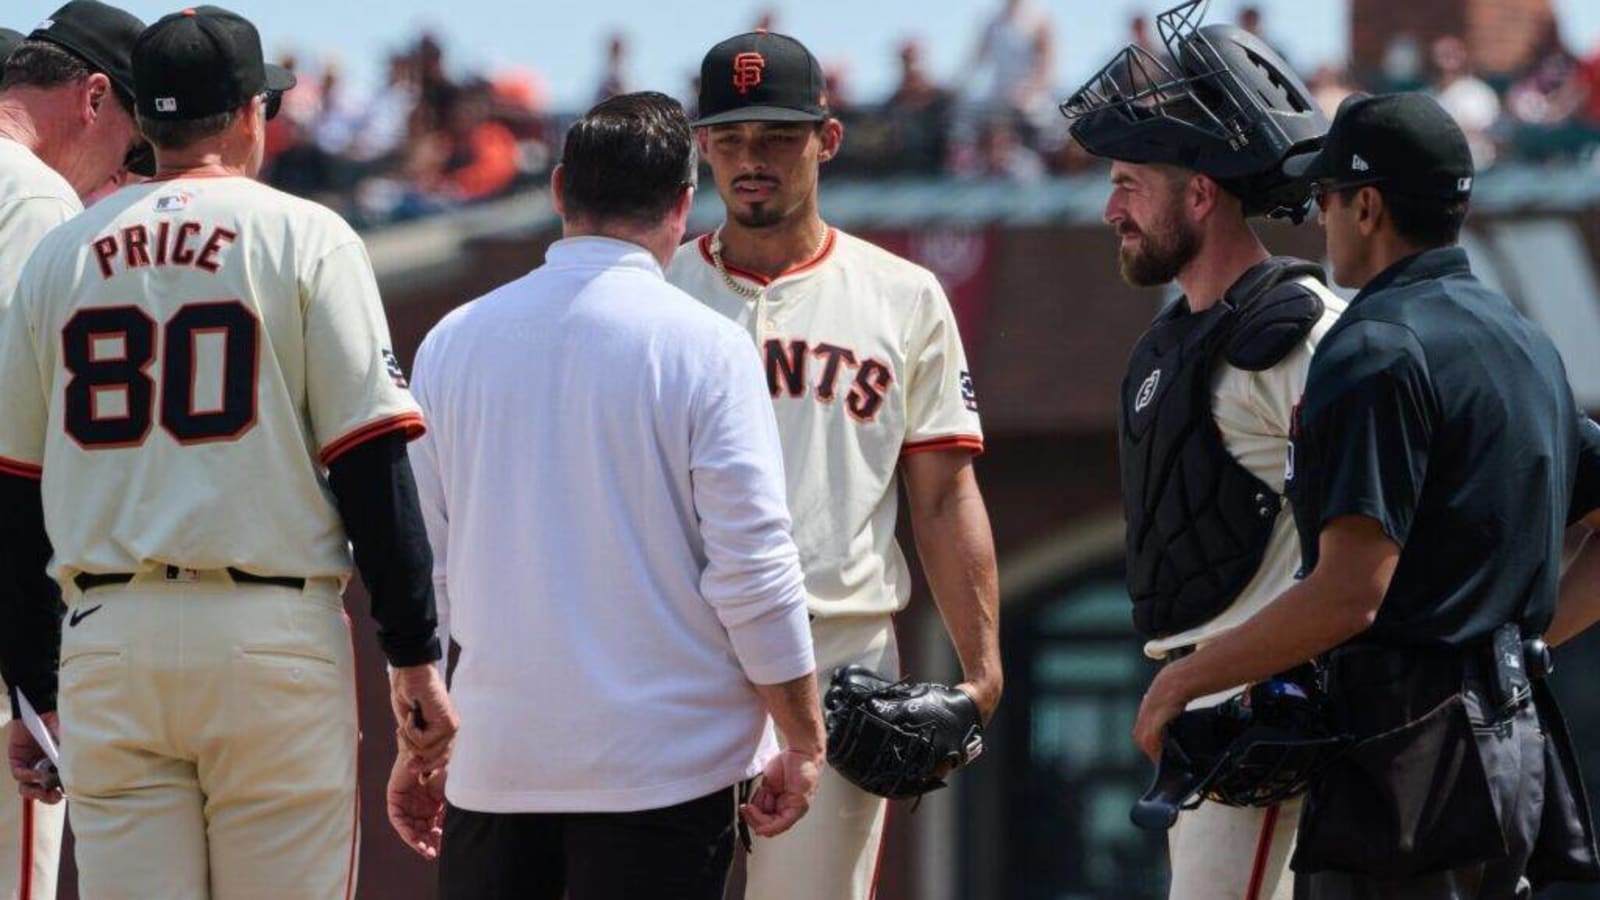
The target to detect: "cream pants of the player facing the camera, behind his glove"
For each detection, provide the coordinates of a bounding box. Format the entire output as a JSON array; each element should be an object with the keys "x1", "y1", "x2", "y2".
[{"x1": 744, "y1": 615, "x2": 899, "y2": 900}]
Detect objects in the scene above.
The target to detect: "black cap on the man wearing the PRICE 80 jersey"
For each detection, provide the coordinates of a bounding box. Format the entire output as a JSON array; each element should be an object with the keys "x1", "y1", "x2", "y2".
[{"x1": 133, "y1": 6, "x2": 294, "y2": 122}]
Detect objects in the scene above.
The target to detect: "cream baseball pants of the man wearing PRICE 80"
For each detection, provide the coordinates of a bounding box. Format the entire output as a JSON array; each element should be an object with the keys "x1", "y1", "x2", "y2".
[{"x1": 59, "y1": 572, "x2": 358, "y2": 900}]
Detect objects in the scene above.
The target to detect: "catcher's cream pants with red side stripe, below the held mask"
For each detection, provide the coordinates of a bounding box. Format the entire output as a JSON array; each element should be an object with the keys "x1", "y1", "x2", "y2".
[{"x1": 1166, "y1": 799, "x2": 1301, "y2": 900}]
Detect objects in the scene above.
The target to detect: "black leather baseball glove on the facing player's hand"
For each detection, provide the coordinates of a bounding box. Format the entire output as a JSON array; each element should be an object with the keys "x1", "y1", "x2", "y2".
[{"x1": 822, "y1": 666, "x2": 984, "y2": 799}]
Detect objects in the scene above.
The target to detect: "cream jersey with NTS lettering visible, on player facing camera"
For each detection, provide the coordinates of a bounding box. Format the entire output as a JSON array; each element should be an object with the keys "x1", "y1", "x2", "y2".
[{"x1": 667, "y1": 229, "x2": 984, "y2": 615}]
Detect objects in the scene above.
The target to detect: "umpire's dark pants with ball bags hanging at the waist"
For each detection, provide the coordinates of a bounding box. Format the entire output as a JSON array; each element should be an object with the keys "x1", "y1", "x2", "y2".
[{"x1": 1294, "y1": 652, "x2": 1546, "y2": 900}]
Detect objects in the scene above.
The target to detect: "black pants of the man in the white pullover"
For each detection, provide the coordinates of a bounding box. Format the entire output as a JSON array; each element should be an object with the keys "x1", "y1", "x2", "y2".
[{"x1": 438, "y1": 786, "x2": 738, "y2": 900}]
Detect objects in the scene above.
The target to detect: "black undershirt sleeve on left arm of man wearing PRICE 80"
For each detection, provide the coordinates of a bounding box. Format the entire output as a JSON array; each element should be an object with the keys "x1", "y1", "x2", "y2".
[{"x1": 0, "y1": 474, "x2": 64, "y2": 717}]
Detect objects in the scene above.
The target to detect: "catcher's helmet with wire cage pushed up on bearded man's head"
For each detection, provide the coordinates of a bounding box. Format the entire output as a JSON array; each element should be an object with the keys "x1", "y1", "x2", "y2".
[{"x1": 1061, "y1": 0, "x2": 1328, "y2": 221}]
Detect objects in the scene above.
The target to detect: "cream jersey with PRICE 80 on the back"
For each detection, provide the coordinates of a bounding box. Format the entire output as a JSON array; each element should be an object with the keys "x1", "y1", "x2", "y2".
[{"x1": 0, "y1": 176, "x2": 422, "y2": 578}]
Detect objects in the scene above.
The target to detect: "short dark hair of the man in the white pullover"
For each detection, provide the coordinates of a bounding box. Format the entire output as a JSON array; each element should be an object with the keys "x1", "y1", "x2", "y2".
[{"x1": 562, "y1": 91, "x2": 696, "y2": 224}]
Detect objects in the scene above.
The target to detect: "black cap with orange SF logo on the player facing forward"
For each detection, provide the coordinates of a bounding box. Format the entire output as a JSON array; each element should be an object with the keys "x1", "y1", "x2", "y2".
[{"x1": 690, "y1": 30, "x2": 827, "y2": 128}]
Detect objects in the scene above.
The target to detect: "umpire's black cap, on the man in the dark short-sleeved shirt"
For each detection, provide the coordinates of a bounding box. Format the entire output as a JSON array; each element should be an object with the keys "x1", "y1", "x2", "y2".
[{"x1": 1283, "y1": 93, "x2": 1474, "y2": 200}]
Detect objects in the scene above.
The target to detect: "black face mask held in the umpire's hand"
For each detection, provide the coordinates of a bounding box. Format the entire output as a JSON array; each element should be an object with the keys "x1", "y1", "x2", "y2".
[{"x1": 1133, "y1": 666, "x2": 1350, "y2": 831}]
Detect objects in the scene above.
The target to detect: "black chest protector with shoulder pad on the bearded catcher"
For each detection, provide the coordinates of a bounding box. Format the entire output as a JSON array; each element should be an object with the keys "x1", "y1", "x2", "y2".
[{"x1": 1118, "y1": 256, "x2": 1323, "y2": 639}]
